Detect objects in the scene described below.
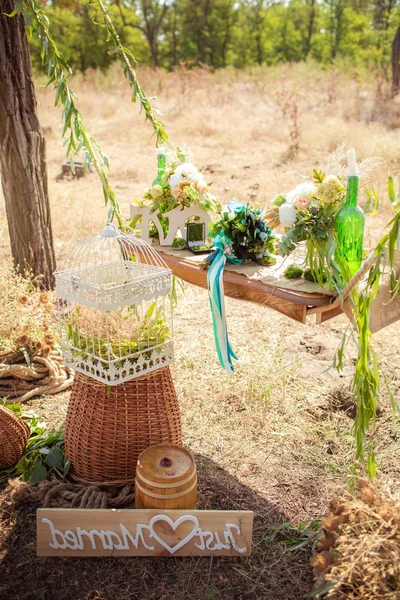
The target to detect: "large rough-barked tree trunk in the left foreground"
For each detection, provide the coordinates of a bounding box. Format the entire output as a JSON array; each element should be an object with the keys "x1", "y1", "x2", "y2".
[{"x1": 0, "y1": 0, "x2": 55, "y2": 289}]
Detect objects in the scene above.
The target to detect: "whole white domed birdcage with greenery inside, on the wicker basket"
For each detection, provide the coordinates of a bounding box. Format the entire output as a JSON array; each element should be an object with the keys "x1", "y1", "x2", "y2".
[{"x1": 55, "y1": 225, "x2": 174, "y2": 385}]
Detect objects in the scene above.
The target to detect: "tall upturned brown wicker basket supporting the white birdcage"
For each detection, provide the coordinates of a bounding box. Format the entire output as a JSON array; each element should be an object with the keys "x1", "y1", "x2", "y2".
[{"x1": 65, "y1": 367, "x2": 182, "y2": 486}]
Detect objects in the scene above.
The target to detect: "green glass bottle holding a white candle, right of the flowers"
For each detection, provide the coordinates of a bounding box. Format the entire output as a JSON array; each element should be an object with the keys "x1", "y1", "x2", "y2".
[{"x1": 337, "y1": 175, "x2": 365, "y2": 276}]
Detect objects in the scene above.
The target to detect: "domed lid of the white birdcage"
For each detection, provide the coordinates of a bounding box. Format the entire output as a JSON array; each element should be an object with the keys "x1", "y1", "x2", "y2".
[{"x1": 55, "y1": 224, "x2": 171, "y2": 310}]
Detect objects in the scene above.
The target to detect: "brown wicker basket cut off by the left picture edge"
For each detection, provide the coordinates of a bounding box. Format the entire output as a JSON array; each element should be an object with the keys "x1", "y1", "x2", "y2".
[{"x1": 0, "y1": 406, "x2": 30, "y2": 469}]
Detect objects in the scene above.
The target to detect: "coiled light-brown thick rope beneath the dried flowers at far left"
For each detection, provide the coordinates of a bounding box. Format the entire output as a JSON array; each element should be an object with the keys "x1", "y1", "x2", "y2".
[{"x1": 0, "y1": 351, "x2": 73, "y2": 402}]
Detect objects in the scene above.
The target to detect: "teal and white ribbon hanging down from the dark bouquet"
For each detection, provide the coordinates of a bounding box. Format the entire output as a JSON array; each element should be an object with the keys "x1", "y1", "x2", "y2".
[{"x1": 207, "y1": 234, "x2": 242, "y2": 373}]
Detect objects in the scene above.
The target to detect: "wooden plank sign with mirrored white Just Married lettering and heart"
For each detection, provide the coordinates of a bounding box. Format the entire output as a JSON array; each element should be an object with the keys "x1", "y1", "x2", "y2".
[{"x1": 37, "y1": 508, "x2": 253, "y2": 556}]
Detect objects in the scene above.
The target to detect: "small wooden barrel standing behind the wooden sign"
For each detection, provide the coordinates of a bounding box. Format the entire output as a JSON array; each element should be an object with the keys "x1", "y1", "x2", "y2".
[{"x1": 135, "y1": 444, "x2": 197, "y2": 509}]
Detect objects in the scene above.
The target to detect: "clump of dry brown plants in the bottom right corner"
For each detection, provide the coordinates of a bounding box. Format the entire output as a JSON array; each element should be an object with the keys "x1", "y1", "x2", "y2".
[{"x1": 312, "y1": 479, "x2": 400, "y2": 600}]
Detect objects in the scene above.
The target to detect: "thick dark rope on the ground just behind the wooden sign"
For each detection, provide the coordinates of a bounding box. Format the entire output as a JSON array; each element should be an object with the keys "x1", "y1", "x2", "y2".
[{"x1": 9, "y1": 477, "x2": 135, "y2": 508}]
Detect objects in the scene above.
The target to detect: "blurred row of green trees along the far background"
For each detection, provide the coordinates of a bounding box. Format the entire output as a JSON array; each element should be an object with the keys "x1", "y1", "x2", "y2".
[{"x1": 31, "y1": 0, "x2": 400, "y2": 86}]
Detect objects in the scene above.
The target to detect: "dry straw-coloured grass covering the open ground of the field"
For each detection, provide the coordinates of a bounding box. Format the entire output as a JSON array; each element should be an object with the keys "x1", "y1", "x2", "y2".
[{"x1": 0, "y1": 65, "x2": 400, "y2": 600}]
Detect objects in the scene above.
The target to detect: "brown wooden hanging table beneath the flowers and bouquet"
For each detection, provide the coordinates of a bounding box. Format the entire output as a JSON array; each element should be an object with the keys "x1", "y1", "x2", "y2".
[{"x1": 157, "y1": 246, "x2": 342, "y2": 323}]
